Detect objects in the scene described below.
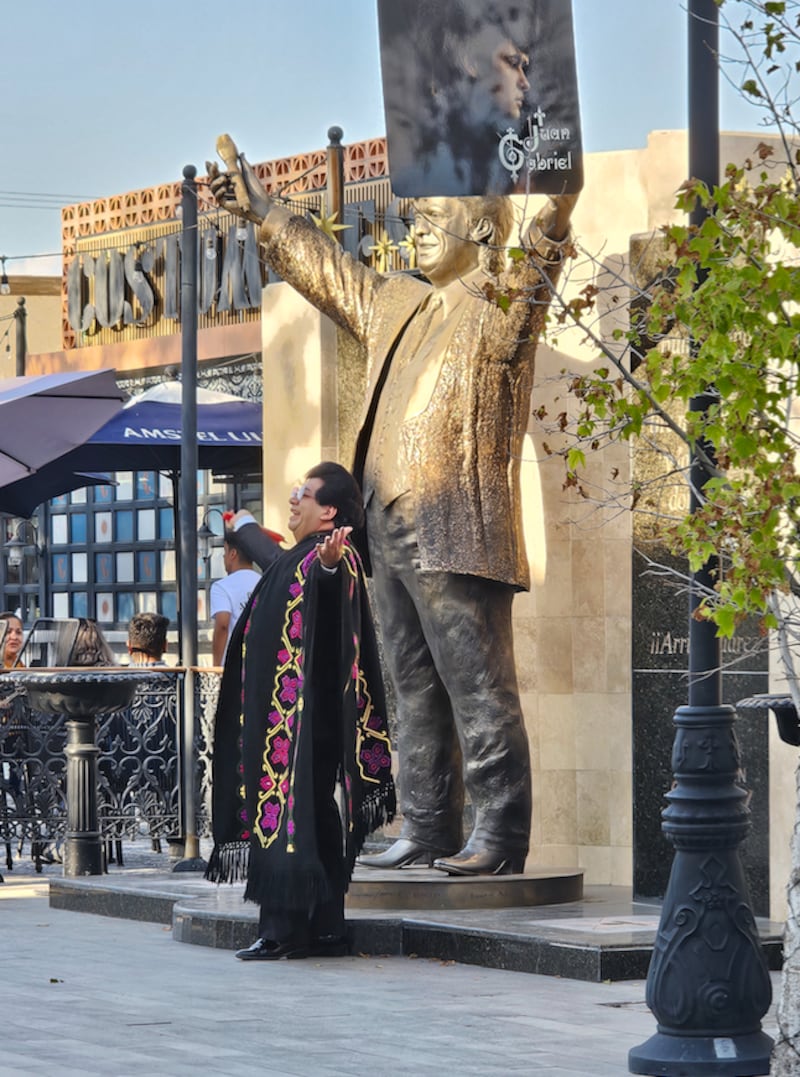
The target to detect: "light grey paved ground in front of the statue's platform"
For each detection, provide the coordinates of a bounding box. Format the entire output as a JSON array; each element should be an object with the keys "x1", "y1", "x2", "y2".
[{"x1": 0, "y1": 843, "x2": 778, "y2": 1077}]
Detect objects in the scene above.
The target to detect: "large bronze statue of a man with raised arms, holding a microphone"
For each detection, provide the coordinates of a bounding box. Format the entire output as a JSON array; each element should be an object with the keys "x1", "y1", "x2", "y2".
[{"x1": 209, "y1": 141, "x2": 576, "y2": 875}]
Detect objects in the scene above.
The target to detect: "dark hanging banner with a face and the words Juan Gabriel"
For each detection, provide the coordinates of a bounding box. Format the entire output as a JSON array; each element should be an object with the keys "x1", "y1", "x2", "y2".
[{"x1": 378, "y1": 0, "x2": 583, "y2": 197}]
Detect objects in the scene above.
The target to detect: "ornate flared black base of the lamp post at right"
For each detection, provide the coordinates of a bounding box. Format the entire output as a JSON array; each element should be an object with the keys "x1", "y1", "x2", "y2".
[{"x1": 628, "y1": 705, "x2": 772, "y2": 1077}]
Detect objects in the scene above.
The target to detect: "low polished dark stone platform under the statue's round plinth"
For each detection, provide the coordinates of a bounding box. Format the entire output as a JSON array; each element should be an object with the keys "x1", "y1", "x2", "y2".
[{"x1": 51, "y1": 872, "x2": 783, "y2": 983}]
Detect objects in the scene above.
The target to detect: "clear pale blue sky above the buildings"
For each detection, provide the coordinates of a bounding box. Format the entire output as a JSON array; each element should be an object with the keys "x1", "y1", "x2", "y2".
[{"x1": 0, "y1": 0, "x2": 775, "y2": 274}]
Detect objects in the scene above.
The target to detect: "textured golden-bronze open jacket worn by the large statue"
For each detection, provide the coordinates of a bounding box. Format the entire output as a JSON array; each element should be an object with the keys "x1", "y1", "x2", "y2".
[{"x1": 265, "y1": 216, "x2": 560, "y2": 590}]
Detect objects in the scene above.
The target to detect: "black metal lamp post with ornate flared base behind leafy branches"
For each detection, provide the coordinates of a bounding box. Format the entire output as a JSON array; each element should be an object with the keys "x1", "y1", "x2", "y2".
[{"x1": 628, "y1": 6, "x2": 772, "y2": 1077}]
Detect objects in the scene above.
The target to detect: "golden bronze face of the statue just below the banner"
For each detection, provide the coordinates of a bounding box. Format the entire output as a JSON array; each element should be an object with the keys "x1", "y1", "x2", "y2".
[{"x1": 415, "y1": 198, "x2": 478, "y2": 288}]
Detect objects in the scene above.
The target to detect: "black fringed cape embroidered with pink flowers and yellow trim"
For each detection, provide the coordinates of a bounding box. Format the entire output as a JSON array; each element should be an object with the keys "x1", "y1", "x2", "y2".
[{"x1": 206, "y1": 535, "x2": 395, "y2": 911}]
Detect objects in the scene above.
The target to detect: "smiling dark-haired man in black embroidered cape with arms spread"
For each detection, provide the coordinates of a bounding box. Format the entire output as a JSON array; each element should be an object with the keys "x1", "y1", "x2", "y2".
[{"x1": 207, "y1": 462, "x2": 395, "y2": 961}]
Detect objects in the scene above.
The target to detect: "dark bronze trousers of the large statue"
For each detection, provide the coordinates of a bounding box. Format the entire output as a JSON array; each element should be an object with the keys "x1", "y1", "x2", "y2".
[{"x1": 367, "y1": 495, "x2": 531, "y2": 855}]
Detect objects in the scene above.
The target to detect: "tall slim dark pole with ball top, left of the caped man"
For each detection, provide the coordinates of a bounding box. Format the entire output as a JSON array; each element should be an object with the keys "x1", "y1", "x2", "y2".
[{"x1": 173, "y1": 165, "x2": 206, "y2": 871}]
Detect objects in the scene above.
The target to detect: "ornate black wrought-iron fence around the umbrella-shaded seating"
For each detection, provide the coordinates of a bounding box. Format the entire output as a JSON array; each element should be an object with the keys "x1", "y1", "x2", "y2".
[{"x1": 0, "y1": 670, "x2": 219, "y2": 867}]
